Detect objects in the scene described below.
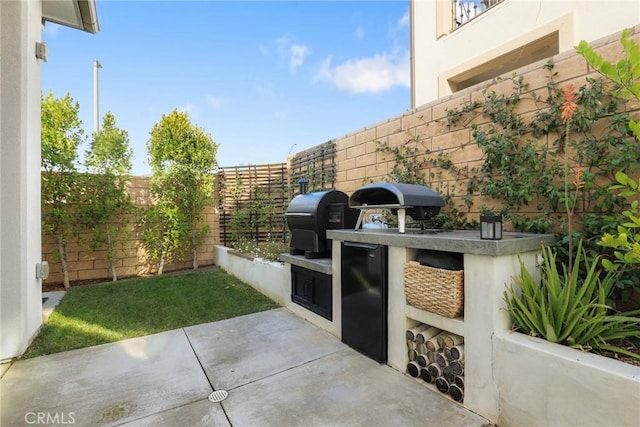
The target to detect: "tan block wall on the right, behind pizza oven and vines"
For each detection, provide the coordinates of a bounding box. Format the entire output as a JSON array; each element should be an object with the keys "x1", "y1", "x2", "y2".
[{"x1": 335, "y1": 25, "x2": 640, "y2": 219}]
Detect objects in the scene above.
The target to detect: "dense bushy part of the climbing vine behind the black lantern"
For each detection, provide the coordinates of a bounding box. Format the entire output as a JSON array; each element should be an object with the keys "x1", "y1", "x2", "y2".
[{"x1": 448, "y1": 63, "x2": 640, "y2": 235}]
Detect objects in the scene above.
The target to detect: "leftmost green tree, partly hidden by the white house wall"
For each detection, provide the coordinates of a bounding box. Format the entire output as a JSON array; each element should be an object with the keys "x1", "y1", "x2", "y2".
[{"x1": 41, "y1": 92, "x2": 84, "y2": 288}]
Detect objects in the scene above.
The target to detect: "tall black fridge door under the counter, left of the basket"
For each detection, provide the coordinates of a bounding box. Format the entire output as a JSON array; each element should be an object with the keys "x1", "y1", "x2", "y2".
[{"x1": 341, "y1": 242, "x2": 387, "y2": 363}]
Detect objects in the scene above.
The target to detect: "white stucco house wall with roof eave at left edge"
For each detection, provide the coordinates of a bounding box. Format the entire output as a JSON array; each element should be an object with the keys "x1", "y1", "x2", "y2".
[{"x1": 0, "y1": 0, "x2": 99, "y2": 360}]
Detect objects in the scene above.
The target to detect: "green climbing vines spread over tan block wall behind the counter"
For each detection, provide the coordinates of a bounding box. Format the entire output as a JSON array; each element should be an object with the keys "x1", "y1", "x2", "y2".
[{"x1": 377, "y1": 62, "x2": 640, "y2": 254}]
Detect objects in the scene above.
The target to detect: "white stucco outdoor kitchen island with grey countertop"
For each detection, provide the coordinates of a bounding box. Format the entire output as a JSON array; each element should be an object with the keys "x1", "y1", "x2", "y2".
[{"x1": 324, "y1": 229, "x2": 554, "y2": 421}]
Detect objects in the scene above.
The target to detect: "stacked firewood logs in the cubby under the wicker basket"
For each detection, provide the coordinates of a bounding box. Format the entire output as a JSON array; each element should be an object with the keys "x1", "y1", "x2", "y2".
[{"x1": 406, "y1": 324, "x2": 464, "y2": 402}]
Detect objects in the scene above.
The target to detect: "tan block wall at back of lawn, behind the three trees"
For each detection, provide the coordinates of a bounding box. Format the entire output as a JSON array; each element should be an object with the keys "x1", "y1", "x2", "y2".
[{"x1": 42, "y1": 177, "x2": 219, "y2": 284}]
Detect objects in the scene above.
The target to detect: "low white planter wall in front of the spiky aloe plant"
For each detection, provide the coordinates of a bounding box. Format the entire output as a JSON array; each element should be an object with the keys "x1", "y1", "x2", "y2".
[{"x1": 493, "y1": 332, "x2": 640, "y2": 427}]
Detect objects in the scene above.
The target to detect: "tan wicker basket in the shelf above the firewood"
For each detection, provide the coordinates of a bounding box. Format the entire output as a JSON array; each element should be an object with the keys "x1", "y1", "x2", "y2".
[{"x1": 404, "y1": 261, "x2": 464, "y2": 318}]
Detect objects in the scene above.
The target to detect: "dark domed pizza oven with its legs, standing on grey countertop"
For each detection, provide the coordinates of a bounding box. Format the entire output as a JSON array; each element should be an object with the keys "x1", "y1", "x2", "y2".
[{"x1": 349, "y1": 182, "x2": 444, "y2": 233}]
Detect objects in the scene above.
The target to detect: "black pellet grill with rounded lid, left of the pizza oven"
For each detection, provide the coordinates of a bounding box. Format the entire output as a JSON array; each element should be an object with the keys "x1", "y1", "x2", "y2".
[{"x1": 287, "y1": 190, "x2": 358, "y2": 259}]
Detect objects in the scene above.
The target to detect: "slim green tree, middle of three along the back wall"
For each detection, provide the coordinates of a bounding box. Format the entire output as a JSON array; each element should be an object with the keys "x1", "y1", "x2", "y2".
[{"x1": 83, "y1": 112, "x2": 133, "y2": 282}]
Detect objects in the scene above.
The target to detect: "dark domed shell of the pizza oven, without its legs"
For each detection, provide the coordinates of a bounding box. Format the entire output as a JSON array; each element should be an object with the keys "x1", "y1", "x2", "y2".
[{"x1": 349, "y1": 182, "x2": 444, "y2": 208}]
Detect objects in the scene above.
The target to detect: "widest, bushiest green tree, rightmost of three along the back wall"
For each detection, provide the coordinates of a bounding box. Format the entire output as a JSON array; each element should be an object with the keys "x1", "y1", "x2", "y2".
[{"x1": 143, "y1": 110, "x2": 218, "y2": 274}]
